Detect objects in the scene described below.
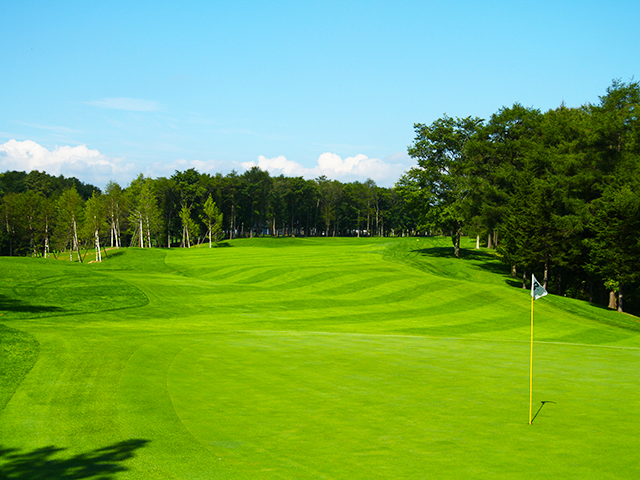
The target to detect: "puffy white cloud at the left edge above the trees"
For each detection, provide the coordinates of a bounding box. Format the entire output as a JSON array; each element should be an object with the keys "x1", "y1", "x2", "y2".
[{"x1": 0, "y1": 140, "x2": 134, "y2": 187}]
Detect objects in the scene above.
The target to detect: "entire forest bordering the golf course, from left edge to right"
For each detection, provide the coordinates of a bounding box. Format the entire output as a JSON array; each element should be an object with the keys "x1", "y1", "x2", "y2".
[{"x1": 0, "y1": 80, "x2": 640, "y2": 313}]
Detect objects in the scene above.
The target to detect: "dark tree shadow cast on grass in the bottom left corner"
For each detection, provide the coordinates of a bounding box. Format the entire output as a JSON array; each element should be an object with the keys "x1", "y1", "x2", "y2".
[{"x1": 0, "y1": 439, "x2": 149, "y2": 480}]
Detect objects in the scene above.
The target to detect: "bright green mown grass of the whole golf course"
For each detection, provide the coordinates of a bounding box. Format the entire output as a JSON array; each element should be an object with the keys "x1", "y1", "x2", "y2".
[{"x1": 0, "y1": 238, "x2": 640, "y2": 479}]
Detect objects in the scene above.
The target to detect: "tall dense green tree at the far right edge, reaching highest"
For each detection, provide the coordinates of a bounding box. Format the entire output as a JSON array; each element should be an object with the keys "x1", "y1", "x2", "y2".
[{"x1": 587, "y1": 80, "x2": 640, "y2": 311}]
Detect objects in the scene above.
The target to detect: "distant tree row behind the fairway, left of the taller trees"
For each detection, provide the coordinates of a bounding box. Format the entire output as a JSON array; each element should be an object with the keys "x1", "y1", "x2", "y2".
[{"x1": 0, "y1": 167, "x2": 415, "y2": 261}]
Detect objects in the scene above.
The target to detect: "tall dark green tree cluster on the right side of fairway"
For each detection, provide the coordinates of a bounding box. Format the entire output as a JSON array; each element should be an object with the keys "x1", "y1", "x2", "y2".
[{"x1": 396, "y1": 81, "x2": 640, "y2": 311}]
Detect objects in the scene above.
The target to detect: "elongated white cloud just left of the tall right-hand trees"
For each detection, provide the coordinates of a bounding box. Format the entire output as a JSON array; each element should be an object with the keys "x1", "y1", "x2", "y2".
[{"x1": 241, "y1": 152, "x2": 407, "y2": 187}]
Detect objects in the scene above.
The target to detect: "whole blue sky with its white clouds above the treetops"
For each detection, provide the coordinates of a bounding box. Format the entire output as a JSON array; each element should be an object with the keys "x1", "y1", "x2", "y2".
[{"x1": 0, "y1": 0, "x2": 640, "y2": 187}]
